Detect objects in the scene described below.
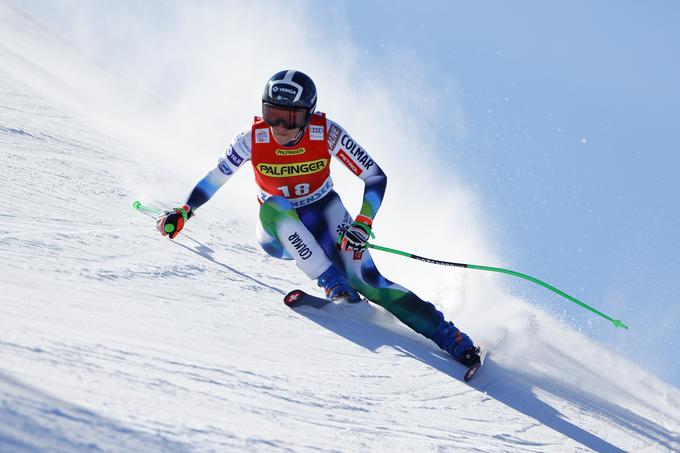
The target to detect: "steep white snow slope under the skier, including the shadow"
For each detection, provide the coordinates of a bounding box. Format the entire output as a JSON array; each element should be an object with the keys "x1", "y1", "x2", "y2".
[{"x1": 0, "y1": 4, "x2": 680, "y2": 451}]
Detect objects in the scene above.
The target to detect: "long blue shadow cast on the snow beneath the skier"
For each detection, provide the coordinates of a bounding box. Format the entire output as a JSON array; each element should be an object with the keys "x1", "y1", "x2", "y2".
[{"x1": 296, "y1": 305, "x2": 674, "y2": 451}]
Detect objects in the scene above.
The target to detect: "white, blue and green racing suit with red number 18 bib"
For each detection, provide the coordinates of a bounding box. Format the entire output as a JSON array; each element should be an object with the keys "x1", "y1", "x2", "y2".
[{"x1": 186, "y1": 112, "x2": 473, "y2": 359}]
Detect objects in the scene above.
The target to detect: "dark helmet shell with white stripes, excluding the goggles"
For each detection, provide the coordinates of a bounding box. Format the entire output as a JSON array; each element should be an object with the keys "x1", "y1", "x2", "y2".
[{"x1": 262, "y1": 70, "x2": 316, "y2": 125}]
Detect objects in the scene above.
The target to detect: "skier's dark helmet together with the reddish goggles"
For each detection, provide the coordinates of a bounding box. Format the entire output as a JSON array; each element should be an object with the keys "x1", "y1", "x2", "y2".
[{"x1": 262, "y1": 70, "x2": 316, "y2": 129}]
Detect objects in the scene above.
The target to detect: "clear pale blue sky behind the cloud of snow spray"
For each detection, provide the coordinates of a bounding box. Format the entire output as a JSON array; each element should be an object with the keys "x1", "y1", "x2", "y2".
[{"x1": 11, "y1": 0, "x2": 680, "y2": 386}]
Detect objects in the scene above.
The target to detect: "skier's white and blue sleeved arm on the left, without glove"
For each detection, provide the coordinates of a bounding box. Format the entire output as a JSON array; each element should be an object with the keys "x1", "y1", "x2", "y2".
[{"x1": 185, "y1": 128, "x2": 251, "y2": 211}]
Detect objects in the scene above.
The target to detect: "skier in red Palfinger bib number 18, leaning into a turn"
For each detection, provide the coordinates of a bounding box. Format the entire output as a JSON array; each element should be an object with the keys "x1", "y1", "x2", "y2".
[{"x1": 157, "y1": 70, "x2": 479, "y2": 366}]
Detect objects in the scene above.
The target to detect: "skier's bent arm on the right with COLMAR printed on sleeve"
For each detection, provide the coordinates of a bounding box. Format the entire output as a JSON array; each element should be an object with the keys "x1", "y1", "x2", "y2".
[{"x1": 327, "y1": 120, "x2": 387, "y2": 222}]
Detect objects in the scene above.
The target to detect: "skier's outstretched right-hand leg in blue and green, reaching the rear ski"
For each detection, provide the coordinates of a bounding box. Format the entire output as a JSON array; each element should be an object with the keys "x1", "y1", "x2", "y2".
[{"x1": 297, "y1": 192, "x2": 473, "y2": 360}]
